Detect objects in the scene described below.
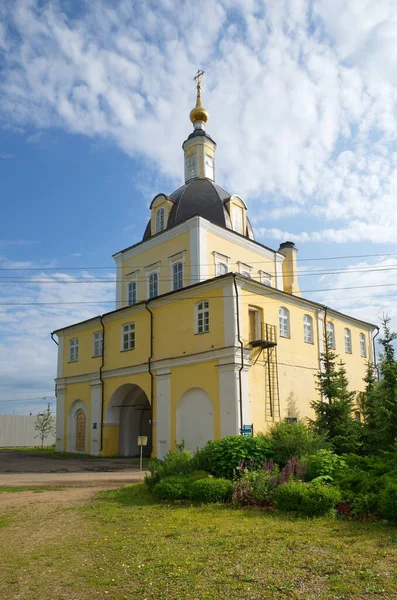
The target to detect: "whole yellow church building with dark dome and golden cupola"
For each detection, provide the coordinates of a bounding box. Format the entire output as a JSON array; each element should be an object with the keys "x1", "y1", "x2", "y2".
[{"x1": 53, "y1": 77, "x2": 376, "y2": 458}]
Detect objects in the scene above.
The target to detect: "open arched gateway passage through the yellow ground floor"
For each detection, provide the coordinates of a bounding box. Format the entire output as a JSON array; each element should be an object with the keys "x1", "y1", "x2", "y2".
[{"x1": 106, "y1": 383, "x2": 152, "y2": 457}]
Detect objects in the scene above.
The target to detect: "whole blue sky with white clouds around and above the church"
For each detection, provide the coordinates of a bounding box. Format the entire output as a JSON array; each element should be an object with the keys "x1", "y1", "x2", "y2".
[{"x1": 0, "y1": 0, "x2": 397, "y2": 413}]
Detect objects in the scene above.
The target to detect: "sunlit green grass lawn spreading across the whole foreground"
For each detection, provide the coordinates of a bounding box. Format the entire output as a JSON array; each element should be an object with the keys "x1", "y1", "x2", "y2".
[{"x1": 0, "y1": 484, "x2": 397, "y2": 600}]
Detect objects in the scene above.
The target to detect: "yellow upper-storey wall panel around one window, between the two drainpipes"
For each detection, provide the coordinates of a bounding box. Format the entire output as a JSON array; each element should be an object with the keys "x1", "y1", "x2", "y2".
[{"x1": 104, "y1": 306, "x2": 150, "y2": 370}]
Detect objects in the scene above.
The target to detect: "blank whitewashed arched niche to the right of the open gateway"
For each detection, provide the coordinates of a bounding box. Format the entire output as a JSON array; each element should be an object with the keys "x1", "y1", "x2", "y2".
[{"x1": 176, "y1": 388, "x2": 214, "y2": 452}]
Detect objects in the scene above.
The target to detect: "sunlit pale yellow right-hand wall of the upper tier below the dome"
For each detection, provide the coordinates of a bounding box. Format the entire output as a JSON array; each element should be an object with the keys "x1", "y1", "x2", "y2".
[{"x1": 207, "y1": 232, "x2": 276, "y2": 287}]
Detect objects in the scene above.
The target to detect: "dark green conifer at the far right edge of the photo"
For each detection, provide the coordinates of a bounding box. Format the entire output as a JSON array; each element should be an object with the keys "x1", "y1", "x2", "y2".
[{"x1": 365, "y1": 316, "x2": 397, "y2": 452}]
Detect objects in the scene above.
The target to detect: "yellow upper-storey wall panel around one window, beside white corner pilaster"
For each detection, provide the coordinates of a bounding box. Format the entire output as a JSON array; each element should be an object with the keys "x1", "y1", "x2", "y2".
[{"x1": 151, "y1": 287, "x2": 224, "y2": 360}]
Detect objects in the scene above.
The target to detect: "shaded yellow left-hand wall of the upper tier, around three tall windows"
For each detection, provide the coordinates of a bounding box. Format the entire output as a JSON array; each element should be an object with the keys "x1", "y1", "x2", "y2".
[{"x1": 122, "y1": 232, "x2": 191, "y2": 302}]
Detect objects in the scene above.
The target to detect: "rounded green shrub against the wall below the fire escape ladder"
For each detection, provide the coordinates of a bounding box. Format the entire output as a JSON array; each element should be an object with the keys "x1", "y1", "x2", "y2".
[{"x1": 263, "y1": 421, "x2": 330, "y2": 465}]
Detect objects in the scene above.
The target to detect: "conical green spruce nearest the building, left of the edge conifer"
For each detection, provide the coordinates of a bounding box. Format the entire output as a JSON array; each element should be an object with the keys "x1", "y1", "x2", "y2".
[{"x1": 311, "y1": 339, "x2": 362, "y2": 454}]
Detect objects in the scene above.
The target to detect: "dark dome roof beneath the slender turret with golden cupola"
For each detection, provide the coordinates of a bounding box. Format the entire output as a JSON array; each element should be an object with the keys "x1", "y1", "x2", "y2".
[{"x1": 143, "y1": 178, "x2": 253, "y2": 240}]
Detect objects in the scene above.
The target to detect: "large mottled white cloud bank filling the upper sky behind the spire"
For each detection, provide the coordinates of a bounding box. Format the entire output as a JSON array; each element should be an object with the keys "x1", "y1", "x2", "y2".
[{"x1": 0, "y1": 0, "x2": 397, "y2": 242}]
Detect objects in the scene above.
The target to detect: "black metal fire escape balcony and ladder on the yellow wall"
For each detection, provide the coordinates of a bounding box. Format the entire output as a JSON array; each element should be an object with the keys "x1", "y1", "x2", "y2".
[{"x1": 249, "y1": 323, "x2": 281, "y2": 422}]
